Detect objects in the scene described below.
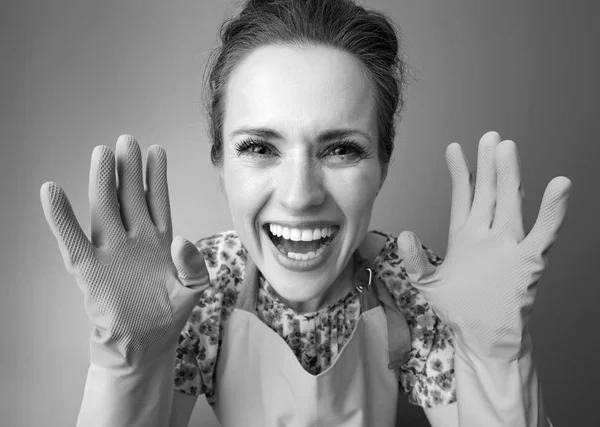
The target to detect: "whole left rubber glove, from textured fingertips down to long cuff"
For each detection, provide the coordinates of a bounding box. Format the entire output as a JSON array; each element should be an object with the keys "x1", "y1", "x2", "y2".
[{"x1": 41, "y1": 135, "x2": 209, "y2": 427}]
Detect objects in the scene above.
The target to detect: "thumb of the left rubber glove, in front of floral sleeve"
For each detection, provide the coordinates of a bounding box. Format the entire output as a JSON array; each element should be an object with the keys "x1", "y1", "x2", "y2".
[{"x1": 171, "y1": 236, "x2": 210, "y2": 288}]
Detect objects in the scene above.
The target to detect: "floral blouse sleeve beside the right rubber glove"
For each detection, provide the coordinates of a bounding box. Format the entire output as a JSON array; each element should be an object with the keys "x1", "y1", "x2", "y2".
[{"x1": 375, "y1": 233, "x2": 456, "y2": 407}]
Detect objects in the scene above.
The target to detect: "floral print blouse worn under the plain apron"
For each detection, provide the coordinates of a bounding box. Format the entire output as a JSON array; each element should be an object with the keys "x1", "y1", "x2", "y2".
[{"x1": 175, "y1": 231, "x2": 456, "y2": 407}]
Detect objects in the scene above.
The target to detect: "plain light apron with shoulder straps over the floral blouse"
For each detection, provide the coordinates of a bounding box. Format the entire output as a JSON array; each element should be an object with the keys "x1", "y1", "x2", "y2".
[{"x1": 214, "y1": 251, "x2": 412, "y2": 427}]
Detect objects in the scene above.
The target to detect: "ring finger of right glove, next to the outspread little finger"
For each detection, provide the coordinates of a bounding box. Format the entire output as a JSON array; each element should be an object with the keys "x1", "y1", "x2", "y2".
[{"x1": 493, "y1": 140, "x2": 525, "y2": 242}]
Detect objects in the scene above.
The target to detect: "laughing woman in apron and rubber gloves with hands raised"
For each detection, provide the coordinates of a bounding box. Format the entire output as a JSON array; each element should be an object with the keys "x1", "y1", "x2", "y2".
[{"x1": 41, "y1": 0, "x2": 570, "y2": 427}]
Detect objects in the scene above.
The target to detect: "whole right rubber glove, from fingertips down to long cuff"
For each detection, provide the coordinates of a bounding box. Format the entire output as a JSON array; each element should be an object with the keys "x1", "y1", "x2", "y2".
[{"x1": 398, "y1": 132, "x2": 571, "y2": 427}]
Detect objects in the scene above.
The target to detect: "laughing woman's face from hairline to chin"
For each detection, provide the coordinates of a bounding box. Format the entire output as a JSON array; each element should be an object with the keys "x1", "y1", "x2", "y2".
[{"x1": 222, "y1": 45, "x2": 382, "y2": 311}]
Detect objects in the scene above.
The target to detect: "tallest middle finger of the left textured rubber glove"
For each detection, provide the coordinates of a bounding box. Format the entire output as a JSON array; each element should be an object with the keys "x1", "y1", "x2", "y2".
[{"x1": 115, "y1": 135, "x2": 150, "y2": 236}]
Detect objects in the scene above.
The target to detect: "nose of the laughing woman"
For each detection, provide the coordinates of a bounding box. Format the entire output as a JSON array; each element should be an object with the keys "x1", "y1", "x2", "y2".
[{"x1": 278, "y1": 159, "x2": 325, "y2": 213}]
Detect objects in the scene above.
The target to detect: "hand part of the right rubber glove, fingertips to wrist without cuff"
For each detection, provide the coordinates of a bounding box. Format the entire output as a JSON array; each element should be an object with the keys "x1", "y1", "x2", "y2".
[{"x1": 398, "y1": 132, "x2": 571, "y2": 360}]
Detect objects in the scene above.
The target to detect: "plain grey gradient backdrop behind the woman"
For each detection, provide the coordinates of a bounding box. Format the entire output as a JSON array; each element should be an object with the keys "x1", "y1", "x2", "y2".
[{"x1": 0, "y1": 0, "x2": 600, "y2": 427}]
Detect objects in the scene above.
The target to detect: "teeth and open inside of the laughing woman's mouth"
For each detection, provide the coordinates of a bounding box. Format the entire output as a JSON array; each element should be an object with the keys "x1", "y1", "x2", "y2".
[{"x1": 265, "y1": 224, "x2": 339, "y2": 260}]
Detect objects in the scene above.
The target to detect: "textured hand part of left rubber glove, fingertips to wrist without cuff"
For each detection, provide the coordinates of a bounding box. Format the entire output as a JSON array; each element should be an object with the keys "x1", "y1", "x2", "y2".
[{"x1": 41, "y1": 135, "x2": 209, "y2": 366}]
